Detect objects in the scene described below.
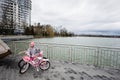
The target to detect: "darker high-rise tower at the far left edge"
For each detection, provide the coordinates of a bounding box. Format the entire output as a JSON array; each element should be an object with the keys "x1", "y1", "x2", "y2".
[{"x1": 0, "y1": 0, "x2": 14, "y2": 29}]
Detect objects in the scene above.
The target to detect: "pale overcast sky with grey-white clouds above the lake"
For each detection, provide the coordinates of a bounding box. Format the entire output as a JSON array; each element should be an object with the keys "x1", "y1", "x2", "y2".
[{"x1": 31, "y1": 0, "x2": 120, "y2": 32}]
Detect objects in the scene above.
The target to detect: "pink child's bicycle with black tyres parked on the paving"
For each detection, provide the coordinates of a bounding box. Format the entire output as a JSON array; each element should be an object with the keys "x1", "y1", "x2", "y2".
[{"x1": 18, "y1": 52, "x2": 50, "y2": 74}]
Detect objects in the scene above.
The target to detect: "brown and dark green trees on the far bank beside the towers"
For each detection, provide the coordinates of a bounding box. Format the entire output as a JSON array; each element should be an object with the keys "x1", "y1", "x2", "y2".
[{"x1": 25, "y1": 23, "x2": 74, "y2": 37}]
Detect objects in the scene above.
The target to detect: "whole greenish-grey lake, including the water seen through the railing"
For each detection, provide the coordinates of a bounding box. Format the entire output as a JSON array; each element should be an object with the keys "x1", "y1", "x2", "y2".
[{"x1": 8, "y1": 37, "x2": 120, "y2": 68}]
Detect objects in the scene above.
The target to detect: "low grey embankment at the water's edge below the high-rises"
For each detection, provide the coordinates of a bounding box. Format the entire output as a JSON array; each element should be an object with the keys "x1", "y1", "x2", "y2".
[{"x1": 0, "y1": 35, "x2": 34, "y2": 41}]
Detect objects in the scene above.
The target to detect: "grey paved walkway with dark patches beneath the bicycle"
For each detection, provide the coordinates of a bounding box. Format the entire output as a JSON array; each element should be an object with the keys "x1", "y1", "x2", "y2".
[{"x1": 0, "y1": 56, "x2": 120, "y2": 80}]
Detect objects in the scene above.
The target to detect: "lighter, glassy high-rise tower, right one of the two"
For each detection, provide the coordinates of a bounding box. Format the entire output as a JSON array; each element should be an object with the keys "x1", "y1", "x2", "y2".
[{"x1": 16, "y1": 0, "x2": 31, "y2": 32}]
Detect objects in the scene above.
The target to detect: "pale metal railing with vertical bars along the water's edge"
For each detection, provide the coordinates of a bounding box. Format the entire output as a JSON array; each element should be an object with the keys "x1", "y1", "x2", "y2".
[{"x1": 9, "y1": 41, "x2": 120, "y2": 69}]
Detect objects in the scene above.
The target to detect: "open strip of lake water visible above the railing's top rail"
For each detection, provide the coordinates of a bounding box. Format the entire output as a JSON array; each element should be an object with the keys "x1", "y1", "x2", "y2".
[{"x1": 29, "y1": 37, "x2": 120, "y2": 48}]
